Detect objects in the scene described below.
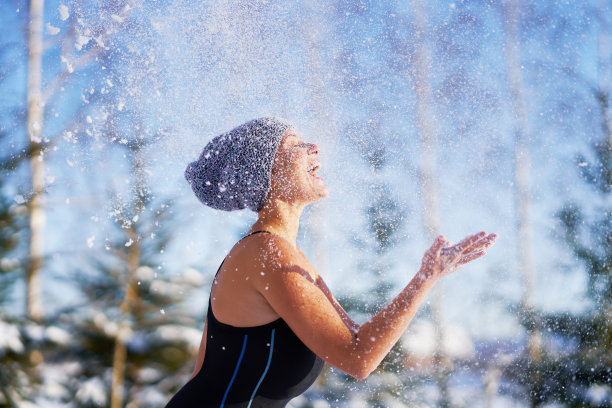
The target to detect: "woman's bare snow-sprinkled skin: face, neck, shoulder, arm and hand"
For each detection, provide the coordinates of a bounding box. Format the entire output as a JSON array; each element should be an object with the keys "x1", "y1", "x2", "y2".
[{"x1": 194, "y1": 130, "x2": 497, "y2": 379}]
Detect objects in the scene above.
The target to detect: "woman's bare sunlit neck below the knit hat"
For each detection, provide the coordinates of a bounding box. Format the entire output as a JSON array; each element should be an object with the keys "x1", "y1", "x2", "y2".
[{"x1": 250, "y1": 200, "x2": 304, "y2": 246}]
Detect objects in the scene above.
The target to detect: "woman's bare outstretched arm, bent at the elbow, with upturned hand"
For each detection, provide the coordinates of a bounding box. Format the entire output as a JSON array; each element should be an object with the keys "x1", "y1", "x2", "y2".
[{"x1": 254, "y1": 233, "x2": 496, "y2": 379}]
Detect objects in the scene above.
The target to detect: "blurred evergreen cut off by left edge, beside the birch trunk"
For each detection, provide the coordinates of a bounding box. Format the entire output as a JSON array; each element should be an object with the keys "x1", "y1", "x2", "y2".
[{"x1": 0, "y1": 16, "x2": 46, "y2": 407}]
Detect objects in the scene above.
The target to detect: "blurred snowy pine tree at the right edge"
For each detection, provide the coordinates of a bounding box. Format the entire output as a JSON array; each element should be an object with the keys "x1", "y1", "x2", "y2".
[{"x1": 547, "y1": 132, "x2": 612, "y2": 406}]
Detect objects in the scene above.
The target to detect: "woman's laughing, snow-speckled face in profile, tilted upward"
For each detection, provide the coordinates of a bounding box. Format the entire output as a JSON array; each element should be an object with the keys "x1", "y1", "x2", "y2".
[{"x1": 271, "y1": 129, "x2": 329, "y2": 205}]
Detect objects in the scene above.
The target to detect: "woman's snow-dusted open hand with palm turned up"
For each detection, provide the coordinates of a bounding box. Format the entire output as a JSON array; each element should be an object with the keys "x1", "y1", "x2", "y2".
[{"x1": 419, "y1": 231, "x2": 497, "y2": 280}]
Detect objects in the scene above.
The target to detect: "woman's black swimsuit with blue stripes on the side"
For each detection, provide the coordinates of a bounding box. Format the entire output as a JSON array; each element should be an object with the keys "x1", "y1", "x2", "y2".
[{"x1": 166, "y1": 231, "x2": 323, "y2": 408}]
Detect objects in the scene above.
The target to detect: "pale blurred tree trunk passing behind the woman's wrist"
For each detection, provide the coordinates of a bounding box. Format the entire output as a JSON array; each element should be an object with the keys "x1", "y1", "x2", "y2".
[{"x1": 412, "y1": 0, "x2": 450, "y2": 408}]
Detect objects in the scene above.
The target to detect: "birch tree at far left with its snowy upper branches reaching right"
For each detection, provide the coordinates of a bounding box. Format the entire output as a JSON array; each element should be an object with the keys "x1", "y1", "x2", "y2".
[{"x1": 21, "y1": 0, "x2": 141, "y2": 321}]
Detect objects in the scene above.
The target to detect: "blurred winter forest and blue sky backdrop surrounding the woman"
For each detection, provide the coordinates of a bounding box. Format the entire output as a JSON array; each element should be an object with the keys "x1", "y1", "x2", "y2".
[{"x1": 0, "y1": 0, "x2": 612, "y2": 408}]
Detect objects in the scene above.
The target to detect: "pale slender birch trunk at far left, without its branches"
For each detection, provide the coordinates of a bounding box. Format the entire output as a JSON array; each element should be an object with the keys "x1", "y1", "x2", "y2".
[{"x1": 26, "y1": 0, "x2": 45, "y2": 321}]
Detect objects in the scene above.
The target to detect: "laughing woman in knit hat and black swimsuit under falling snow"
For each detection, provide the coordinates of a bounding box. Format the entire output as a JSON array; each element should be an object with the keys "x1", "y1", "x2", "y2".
[{"x1": 167, "y1": 118, "x2": 496, "y2": 408}]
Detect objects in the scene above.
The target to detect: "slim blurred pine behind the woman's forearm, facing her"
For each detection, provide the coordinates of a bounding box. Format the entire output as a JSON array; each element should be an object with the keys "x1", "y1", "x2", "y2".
[{"x1": 332, "y1": 112, "x2": 405, "y2": 407}]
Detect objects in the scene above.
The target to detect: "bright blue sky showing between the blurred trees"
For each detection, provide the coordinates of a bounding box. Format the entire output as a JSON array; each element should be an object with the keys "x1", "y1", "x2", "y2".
[{"x1": 0, "y1": 0, "x2": 599, "y2": 337}]
